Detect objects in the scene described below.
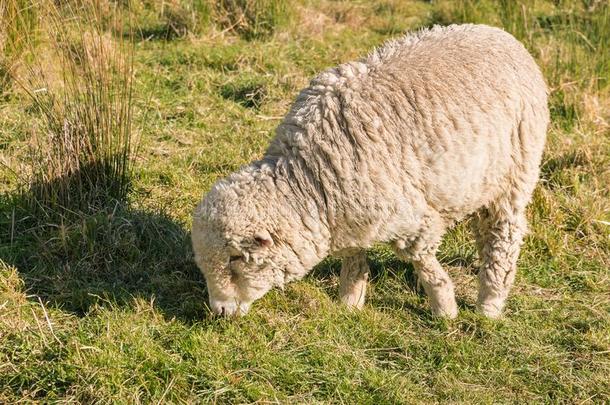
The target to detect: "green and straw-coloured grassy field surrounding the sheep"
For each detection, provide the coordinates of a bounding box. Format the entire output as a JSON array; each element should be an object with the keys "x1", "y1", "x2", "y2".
[{"x1": 0, "y1": 0, "x2": 610, "y2": 404}]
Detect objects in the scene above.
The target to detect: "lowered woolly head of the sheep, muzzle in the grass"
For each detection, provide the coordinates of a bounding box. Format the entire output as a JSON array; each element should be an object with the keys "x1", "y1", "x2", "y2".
[{"x1": 192, "y1": 174, "x2": 299, "y2": 316}]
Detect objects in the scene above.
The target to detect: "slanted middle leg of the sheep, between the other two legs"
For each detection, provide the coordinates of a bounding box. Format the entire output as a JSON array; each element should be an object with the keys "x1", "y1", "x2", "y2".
[{"x1": 413, "y1": 255, "x2": 458, "y2": 318}]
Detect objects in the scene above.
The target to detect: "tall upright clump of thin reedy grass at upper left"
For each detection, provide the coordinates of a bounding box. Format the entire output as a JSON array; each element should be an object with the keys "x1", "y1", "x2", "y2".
[{"x1": 21, "y1": 0, "x2": 134, "y2": 212}]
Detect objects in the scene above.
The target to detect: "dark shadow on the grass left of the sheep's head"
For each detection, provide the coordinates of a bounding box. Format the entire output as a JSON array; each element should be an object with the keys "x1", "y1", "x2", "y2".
[{"x1": 0, "y1": 166, "x2": 209, "y2": 322}]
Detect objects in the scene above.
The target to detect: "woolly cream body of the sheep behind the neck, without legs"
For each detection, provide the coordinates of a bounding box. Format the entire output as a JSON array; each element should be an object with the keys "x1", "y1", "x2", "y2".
[{"x1": 268, "y1": 25, "x2": 548, "y2": 243}]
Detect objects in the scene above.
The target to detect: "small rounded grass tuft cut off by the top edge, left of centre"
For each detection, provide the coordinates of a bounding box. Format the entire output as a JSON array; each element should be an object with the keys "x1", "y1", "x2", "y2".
[{"x1": 216, "y1": 0, "x2": 291, "y2": 40}]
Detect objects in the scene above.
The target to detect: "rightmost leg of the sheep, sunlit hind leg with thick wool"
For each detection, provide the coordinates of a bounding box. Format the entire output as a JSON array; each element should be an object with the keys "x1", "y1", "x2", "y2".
[{"x1": 474, "y1": 209, "x2": 527, "y2": 318}]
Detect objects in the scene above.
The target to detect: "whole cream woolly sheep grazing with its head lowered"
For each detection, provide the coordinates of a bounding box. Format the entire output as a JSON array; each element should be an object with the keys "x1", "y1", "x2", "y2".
[{"x1": 192, "y1": 25, "x2": 549, "y2": 317}]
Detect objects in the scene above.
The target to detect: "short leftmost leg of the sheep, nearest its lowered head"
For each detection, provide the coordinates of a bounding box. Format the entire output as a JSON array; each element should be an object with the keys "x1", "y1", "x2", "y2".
[{"x1": 339, "y1": 251, "x2": 369, "y2": 309}]
